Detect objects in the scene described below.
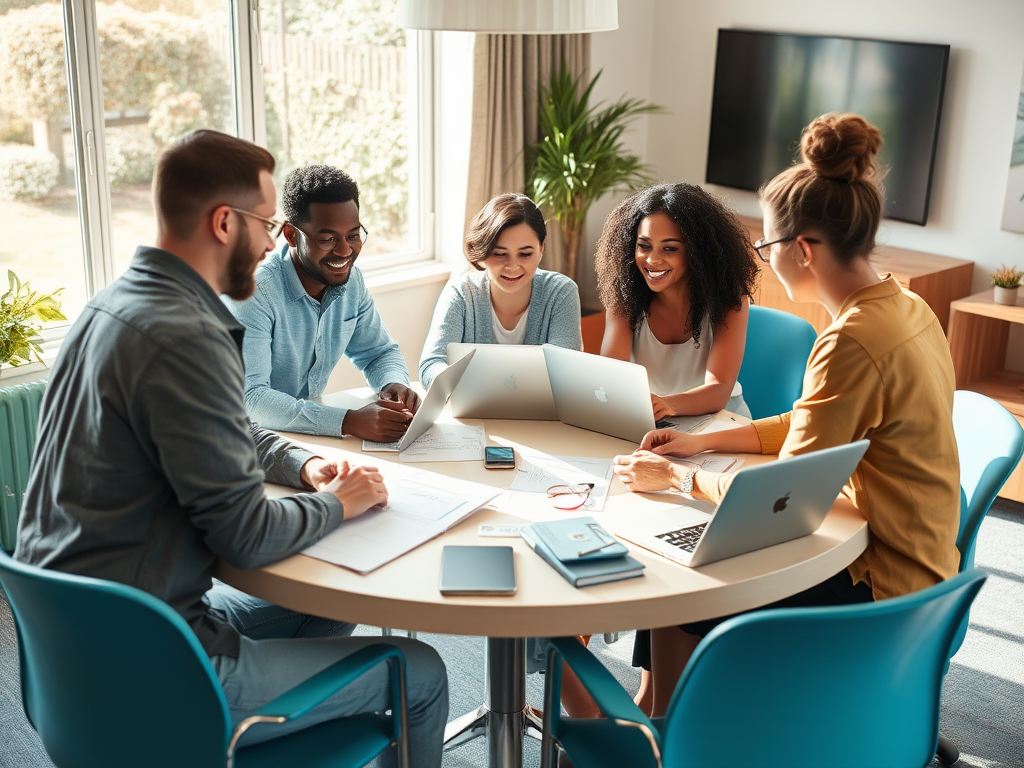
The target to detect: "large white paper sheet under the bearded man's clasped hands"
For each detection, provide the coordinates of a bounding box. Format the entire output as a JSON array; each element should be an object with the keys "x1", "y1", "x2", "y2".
[{"x1": 303, "y1": 466, "x2": 501, "y2": 573}]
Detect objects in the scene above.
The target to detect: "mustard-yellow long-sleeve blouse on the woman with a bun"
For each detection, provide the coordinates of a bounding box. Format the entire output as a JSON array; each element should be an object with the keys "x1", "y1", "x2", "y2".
[{"x1": 693, "y1": 275, "x2": 959, "y2": 600}]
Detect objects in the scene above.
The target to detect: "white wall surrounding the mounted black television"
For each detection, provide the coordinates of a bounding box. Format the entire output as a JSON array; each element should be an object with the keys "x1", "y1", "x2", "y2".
[{"x1": 587, "y1": 0, "x2": 1024, "y2": 348}]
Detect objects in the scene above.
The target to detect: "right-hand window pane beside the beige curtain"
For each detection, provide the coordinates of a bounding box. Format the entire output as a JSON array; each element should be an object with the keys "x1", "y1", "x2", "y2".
[{"x1": 259, "y1": 0, "x2": 427, "y2": 268}]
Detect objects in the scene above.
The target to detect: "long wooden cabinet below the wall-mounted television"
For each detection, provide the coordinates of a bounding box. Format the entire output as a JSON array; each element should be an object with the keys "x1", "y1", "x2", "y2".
[{"x1": 740, "y1": 216, "x2": 974, "y2": 333}]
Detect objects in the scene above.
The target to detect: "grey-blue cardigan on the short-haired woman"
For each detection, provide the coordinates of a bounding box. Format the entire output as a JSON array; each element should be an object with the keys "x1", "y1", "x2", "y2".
[{"x1": 420, "y1": 269, "x2": 583, "y2": 387}]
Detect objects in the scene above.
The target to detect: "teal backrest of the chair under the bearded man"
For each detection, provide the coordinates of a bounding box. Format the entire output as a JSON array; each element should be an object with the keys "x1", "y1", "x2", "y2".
[{"x1": 0, "y1": 552, "x2": 230, "y2": 768}]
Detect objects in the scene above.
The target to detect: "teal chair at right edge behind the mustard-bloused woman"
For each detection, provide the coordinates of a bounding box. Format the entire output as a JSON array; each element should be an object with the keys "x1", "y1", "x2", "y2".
[{"x1": 938, "y1": 390, "x2": 1024, "y2": 765}]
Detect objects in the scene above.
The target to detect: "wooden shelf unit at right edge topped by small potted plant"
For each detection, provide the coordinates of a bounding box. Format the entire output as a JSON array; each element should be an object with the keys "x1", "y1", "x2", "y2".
[{"x1": 948, "y1": 289, "x2": 1024, "y2": 502}]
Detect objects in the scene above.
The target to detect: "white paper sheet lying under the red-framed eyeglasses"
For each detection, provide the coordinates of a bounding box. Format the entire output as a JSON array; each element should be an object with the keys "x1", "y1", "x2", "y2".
[{"x1": 494, "y1": 451, "x2": 611, "y2": 519}]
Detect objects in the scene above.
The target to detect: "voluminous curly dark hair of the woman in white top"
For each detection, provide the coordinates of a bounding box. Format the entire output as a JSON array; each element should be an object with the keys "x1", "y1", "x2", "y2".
[{"x1": 595, "y1": 182, "x2": 759, "y2": 345}]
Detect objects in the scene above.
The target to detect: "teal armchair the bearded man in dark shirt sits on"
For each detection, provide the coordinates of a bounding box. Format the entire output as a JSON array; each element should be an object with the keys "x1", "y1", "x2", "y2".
[{"x1": 0, "y1": 552, "x2": 410, "y2": 768}]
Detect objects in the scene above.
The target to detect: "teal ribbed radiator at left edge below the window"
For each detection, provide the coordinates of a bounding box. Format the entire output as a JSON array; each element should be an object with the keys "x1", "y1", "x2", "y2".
[{"x1": 0, "y1": 381, "x2": 46, "y2": 552}]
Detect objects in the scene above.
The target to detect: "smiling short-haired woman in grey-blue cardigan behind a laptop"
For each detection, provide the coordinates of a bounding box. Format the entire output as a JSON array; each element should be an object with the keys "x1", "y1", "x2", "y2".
[{"x1": 420, "y1": 193, "x2": 583, "y2": 387}]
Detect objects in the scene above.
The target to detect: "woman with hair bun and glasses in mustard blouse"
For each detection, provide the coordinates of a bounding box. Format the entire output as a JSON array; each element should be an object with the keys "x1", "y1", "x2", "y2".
[{"x1": 615, "y1": 115, "x2": 959, "y2": 714}]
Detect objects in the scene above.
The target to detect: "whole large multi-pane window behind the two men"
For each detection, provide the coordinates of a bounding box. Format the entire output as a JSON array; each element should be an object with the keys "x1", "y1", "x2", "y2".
[{"x1": 0, "y1": 0, "x2": 432, "y2": 333}]
